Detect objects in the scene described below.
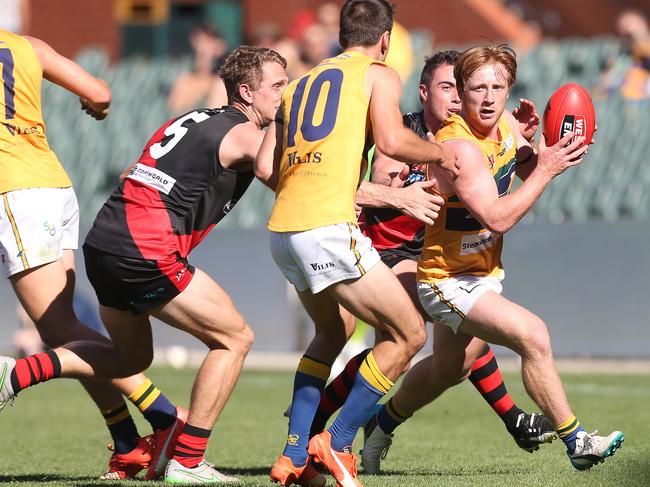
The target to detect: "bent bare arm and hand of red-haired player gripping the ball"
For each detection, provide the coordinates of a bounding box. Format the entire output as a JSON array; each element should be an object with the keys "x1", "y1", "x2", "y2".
[{"x1": 444, "y1": 133, "x2": 587, "y2": 234}]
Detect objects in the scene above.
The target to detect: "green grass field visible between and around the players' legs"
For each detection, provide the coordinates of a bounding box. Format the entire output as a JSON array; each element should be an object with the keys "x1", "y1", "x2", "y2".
[{"x1": 0, "y1": 368, "x2": 650, "y2": 487}]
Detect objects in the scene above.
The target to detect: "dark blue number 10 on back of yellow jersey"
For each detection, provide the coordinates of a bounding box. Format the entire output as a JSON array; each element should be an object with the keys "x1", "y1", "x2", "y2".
[{"x1": 287, "y1": 69, "x2": 343, "y2": 147}]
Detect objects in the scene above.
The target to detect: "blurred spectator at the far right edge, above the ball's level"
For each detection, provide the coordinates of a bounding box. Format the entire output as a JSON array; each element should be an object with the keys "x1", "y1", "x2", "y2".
[{"x1": 594, "y1": 10, "x2": 650, "y2": 100}]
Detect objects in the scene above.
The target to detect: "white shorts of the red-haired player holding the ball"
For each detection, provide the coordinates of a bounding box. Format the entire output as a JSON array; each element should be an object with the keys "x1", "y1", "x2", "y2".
[{"x1": 418, "y1": 274, "x2": 503, "y2": 333}]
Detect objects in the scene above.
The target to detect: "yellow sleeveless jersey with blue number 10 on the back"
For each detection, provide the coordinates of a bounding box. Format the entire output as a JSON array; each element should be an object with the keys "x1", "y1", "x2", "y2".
[{"x1": 268, "y1": 51, "x2": 382, "y2": 232}]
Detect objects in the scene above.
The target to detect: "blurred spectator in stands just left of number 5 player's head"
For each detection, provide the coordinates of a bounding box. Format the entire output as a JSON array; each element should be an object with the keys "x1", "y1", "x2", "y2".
[{"x1": 167, "y1": 24, "x2": 228, "y2": 114}]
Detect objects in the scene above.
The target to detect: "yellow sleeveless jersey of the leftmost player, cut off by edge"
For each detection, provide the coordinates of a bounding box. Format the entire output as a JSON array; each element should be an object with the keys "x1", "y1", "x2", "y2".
[{"x1": 0, "y1": 30, "x2": 72, "y2": 193}]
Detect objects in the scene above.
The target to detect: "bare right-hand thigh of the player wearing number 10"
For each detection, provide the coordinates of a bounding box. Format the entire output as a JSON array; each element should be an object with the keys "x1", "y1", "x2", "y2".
[{"x1": 328, "y1": 262, "x2": 424, "y2": 336}]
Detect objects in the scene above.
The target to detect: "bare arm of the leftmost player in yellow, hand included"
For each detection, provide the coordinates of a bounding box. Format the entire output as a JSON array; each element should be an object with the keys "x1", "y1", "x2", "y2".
[{"x1": 25, "y1": 36, "x2": 111, "y2": 120}]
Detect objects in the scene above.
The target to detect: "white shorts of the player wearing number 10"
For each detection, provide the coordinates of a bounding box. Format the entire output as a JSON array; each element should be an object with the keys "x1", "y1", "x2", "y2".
[{"x1": 271, "y1": 223, "x2": 380, "y2": 294}]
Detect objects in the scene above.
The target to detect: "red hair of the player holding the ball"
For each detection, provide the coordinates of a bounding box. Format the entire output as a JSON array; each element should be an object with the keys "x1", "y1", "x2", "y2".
[{"x1": 454, "y1": 44, "x2": 517, "y2": 94}]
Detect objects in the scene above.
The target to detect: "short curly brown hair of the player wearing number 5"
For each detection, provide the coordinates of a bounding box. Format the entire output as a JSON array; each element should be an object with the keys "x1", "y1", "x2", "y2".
[{"x1": 219, "y1": 46, "x2": 287, "y2": 103}]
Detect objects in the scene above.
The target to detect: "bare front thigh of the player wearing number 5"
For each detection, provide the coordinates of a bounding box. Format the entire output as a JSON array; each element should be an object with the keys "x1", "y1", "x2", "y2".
[{"x1": 151, "y1": 269, "x2": 253, "y2": 349}]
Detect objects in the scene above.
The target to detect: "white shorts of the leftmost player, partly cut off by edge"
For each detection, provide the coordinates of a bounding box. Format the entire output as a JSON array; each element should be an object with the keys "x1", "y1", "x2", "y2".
[{"x1": 0, "y1": 188, "x2": 79, "y2": 277}]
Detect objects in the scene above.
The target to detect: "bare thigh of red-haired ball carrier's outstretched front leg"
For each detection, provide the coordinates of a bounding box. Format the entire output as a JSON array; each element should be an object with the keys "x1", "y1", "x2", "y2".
[{"x1": 459, "y1": 291, "x2": 548, "y2": 352}]
